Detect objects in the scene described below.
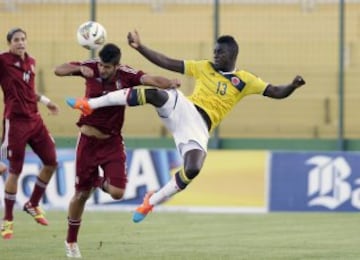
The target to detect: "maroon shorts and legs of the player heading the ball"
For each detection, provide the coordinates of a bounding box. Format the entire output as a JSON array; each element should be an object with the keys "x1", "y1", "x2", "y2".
[{"x1": 65, "y1": 134, "x2": 127, "y2": 258}]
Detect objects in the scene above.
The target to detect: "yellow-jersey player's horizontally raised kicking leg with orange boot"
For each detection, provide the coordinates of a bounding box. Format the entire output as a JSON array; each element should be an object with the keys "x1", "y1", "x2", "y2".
[{"x1": 66, "y1": 88, "x2": 168, "y2": 115}]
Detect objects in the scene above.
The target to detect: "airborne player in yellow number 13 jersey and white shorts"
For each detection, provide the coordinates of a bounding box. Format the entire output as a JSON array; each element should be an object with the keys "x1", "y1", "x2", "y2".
[{"x1": 67, "y1": 31, "x2": 305, "y2": 222}]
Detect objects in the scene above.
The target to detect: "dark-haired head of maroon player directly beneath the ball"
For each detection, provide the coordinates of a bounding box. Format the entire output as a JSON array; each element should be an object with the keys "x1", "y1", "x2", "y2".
[{"x1": 98, "y1": 43, "x2": 121, "y2": 80}]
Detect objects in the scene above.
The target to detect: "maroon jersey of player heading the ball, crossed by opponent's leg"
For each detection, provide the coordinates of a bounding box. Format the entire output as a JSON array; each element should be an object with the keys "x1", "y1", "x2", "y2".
[{"x1": 72, "y1": 60, "x2": 144, "y2": 135}]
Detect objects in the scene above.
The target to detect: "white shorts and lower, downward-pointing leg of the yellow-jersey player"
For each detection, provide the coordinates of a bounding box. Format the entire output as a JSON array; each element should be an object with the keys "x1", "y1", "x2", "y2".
[{"x1": 133, "y1": 90, "x2": 209, "y2": 223}]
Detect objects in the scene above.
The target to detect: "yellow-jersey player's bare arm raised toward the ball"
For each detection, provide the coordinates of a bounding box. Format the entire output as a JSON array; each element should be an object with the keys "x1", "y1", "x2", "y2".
[{"x1": 128, "y1": 30, "x2": 184, "y2": 73}]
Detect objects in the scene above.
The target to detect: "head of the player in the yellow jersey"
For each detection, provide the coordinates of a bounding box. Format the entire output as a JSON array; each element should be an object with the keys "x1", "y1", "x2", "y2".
[{"x1": 214, "y1": 35, "x2": 239, "y2": 71}]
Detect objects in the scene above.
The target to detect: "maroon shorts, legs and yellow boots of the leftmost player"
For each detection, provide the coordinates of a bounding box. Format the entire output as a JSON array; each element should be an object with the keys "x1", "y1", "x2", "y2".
[{"x1": 1, "y1": 124, "x2": 57, "y2": 239}]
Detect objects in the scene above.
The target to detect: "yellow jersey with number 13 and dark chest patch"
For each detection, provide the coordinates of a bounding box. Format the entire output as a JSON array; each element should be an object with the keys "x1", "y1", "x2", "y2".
[{"x1": 184, "y1": 60, "x2": 267, "y2": 132}]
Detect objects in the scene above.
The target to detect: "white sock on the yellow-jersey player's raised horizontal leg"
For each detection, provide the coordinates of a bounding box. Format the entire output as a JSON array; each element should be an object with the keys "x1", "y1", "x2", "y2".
[{"x1": 88, "y1": 88, "x2": 131, "y2": 109}]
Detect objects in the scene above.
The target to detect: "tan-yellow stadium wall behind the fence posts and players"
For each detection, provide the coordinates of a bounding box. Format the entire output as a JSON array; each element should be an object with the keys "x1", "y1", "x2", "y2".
[{"x1": 0, "y1": 1, "x2": 360, "y2": 140}]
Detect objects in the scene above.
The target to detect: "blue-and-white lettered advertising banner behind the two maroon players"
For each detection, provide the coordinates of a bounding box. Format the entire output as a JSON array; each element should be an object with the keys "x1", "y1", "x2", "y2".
[{"x1": 0, "y1": 149, "x2": 182, "y2": 208}]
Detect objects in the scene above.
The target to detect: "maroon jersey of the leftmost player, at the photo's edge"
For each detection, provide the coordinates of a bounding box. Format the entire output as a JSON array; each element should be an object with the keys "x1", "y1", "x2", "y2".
[{"x1": 0, "y1": 52, "x2": 40, "y2": 119}]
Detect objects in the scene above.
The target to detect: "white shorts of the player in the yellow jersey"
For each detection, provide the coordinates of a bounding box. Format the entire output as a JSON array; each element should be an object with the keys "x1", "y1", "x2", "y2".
[{"x1": 156, "y1": 89, "x2": 209, "y2": 157}]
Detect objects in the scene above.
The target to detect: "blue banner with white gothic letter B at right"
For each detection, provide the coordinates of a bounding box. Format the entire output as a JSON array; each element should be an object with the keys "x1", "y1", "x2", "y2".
[{"x1": 269, "y1": 152, "x2": 360, "y2": 211}]
